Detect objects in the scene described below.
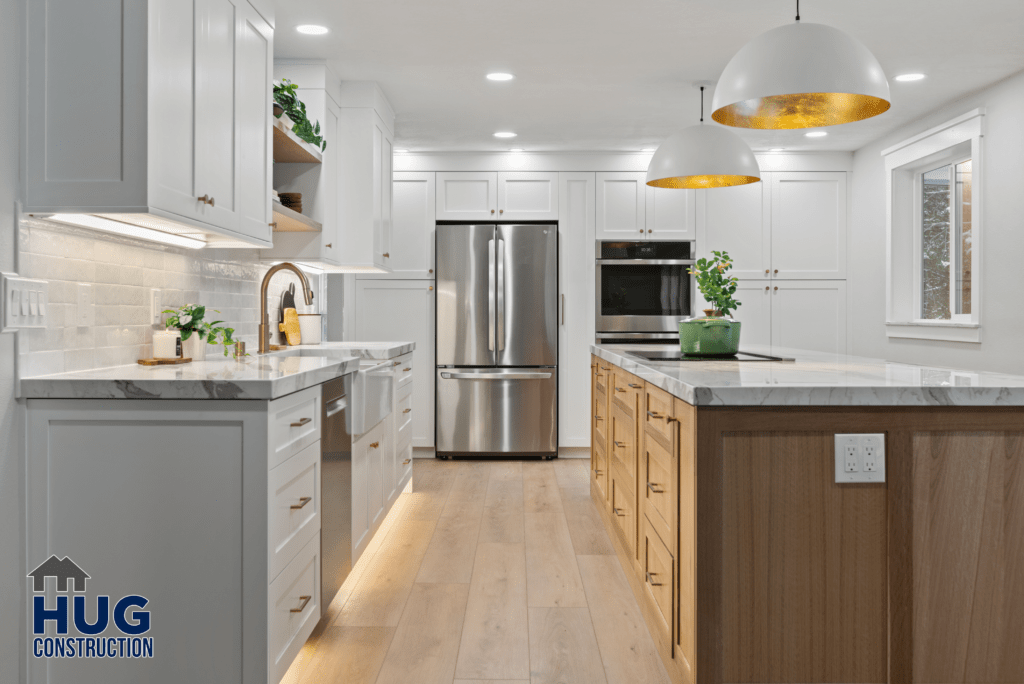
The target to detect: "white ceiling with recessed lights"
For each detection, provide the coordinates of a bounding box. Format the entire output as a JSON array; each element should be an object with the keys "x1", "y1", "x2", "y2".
[{"x1": 274, "y1": 0, "x2": 1024, "y2": 152}]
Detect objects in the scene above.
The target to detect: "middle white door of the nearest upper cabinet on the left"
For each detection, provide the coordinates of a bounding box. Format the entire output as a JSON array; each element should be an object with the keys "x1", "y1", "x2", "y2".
[{"x1": 195, "y1": 0, "x2": 244, "y2": 230}]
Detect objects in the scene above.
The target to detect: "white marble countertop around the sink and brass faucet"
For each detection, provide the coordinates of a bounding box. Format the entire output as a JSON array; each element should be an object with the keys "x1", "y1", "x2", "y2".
[{"x1": 22, "y1": 342, "x2": 416, "y2": 399}]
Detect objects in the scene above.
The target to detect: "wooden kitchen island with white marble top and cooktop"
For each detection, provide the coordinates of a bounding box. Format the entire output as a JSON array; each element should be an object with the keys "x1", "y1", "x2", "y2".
[{"x1": 591, "y1": 345, "x2": 1024, "y2": 684}]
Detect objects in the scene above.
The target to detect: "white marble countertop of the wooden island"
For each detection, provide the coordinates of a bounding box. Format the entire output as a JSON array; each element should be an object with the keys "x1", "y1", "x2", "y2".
[{"x1": 591, "y1": 344, "x2": 1024, "y2": 407}]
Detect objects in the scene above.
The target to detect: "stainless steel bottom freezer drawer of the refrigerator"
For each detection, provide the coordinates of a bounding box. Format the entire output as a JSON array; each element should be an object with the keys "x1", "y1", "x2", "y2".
[{"x1": 436, "y1": 368, "x2": 558, "y2": 455}]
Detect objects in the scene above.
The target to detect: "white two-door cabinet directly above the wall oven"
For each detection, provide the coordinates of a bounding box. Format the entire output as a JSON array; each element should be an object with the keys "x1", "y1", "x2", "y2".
[{"x1": 597, "y1": 172, "x2": 696, "y2": 241}]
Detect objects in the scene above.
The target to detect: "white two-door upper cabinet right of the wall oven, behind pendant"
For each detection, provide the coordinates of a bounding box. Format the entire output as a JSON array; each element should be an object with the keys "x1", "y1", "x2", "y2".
[{"x1": 697, "y1": 171, "x2": 847, "y2": 281}]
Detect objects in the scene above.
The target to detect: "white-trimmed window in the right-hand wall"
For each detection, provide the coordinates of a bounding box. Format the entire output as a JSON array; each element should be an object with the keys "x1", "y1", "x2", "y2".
[{"x1": 882, "y1": 110, "x2": 984, "y2": 342}]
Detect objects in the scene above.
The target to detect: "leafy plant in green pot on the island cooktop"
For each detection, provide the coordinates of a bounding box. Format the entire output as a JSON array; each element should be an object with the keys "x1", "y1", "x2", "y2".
[{"x1": 679, "y1": 252, "x2": 740, "y2": 356}]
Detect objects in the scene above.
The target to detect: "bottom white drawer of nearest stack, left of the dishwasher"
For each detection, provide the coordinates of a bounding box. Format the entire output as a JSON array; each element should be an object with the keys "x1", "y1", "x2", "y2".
[{"x1": 267, "y1": 537, "x2": 321, "y2": 682}]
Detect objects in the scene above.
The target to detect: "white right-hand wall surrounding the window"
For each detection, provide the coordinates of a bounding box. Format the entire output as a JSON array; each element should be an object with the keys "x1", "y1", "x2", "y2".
[{"x1": 847, "y1": 72, "x2": 1024, "y2": 374}]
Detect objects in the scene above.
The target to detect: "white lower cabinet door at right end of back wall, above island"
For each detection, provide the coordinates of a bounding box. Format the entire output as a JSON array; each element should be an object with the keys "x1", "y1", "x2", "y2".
[{"x1": 770, "y1": 281, "x2": 847, "y2": 354}]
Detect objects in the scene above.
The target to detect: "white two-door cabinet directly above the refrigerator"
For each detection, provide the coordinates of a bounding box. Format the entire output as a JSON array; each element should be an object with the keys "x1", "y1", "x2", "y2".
[{"x1": 435, "y1": 171, "x2": 558, "y2": 221}]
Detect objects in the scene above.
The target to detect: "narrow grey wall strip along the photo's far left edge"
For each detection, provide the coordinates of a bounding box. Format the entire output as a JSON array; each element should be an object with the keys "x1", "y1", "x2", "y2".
[{"x1": 0, "y1": 0, "x2": 26, "y2": 684}]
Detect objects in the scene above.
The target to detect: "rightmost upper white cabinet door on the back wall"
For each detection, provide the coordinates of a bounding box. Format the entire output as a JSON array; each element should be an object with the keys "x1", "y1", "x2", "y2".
[{"x1": 771, "y1": 171, "x2": 846, "y2": 280}]
